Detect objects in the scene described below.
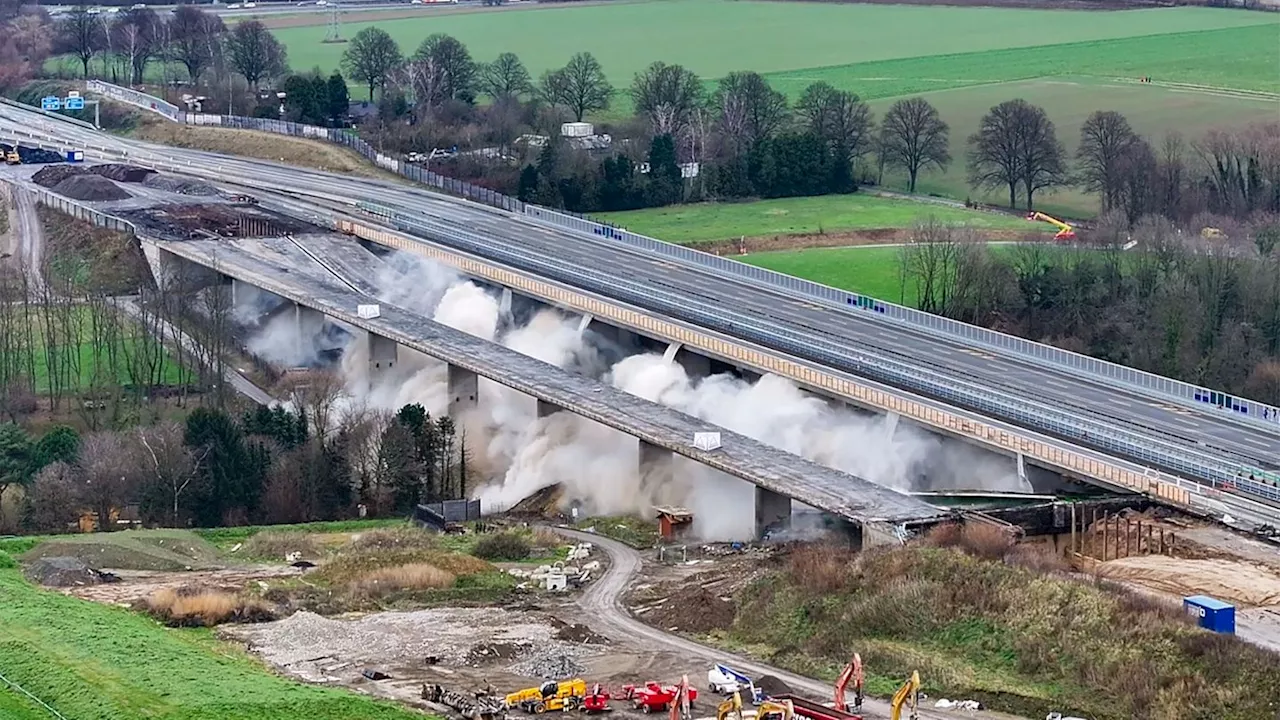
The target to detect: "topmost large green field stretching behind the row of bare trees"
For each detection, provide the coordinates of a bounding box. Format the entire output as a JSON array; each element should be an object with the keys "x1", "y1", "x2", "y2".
[{"x1": 267, "y1": 0, "x2": 1277, "y2": 86}]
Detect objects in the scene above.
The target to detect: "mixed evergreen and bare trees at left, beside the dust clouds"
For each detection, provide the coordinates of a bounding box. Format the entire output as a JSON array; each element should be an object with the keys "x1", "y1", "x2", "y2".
[{"x1": 0, "y1": 394, "x2": 467, "y2": 532}]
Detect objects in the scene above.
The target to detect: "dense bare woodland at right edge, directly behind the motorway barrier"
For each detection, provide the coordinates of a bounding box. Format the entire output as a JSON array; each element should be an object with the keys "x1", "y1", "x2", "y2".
[{"x1": 899, "y1": 213, "x2": 1280, "y2": 404}]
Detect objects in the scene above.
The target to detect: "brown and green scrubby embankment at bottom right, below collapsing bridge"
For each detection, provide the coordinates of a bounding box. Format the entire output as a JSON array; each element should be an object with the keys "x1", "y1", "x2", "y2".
[{"x1": 722, "y1": 538, "x2": 1280, "y2": 720}]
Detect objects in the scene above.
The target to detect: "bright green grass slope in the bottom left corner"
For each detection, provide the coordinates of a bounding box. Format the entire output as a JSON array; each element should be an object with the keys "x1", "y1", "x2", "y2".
[{"x1": 0, "y1": 569, "x2": 422, "y2": 720}]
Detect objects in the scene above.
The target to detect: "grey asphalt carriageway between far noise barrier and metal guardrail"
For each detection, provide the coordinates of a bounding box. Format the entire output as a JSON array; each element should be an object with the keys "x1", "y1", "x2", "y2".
[{"x1": 6, "y1": 109, "x2": 1280, "y2": 481}]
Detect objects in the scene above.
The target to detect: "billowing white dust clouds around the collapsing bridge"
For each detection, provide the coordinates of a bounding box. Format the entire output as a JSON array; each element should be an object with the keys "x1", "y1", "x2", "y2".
[{"x1": 238, "y1": 248, "x2": 1028, "y2": 539}]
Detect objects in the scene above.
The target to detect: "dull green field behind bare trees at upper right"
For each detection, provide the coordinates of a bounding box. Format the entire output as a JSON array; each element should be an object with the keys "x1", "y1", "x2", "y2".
[{"x1": 870, "y1": 77, "x2": 1280, "y2": 217}]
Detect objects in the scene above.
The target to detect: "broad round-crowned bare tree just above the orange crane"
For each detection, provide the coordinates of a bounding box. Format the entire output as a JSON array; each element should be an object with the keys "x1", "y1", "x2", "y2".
[{"x1": 969, "y1": 99, "x2": 1066, "y2": 210}]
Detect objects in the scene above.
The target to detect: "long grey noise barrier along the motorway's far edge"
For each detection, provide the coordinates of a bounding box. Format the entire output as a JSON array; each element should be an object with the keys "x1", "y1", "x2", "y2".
[{"x1": 88, "y1": 81, "x2": 1280, "y2": 428}]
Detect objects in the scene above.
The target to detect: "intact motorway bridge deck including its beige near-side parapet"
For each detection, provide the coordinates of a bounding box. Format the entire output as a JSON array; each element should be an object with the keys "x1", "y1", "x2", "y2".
[{"x1": 0, "y1": 96, "x2": 1280, "y2": 527}]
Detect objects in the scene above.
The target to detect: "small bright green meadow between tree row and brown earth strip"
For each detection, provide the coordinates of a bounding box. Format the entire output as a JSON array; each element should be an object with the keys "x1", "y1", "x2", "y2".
[{"x1": 594, "y1": 193, "x2": 1037, "y2": 245}]
